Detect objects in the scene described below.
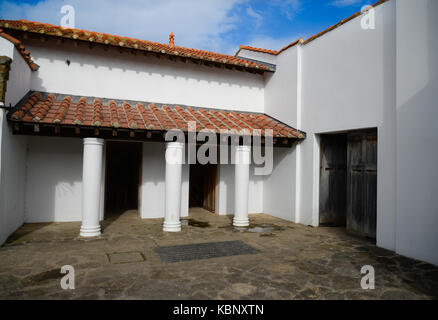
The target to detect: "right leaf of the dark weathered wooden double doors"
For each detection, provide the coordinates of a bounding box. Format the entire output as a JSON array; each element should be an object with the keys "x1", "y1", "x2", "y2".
[{"x1": 347, "y1": 130, "x2": 377, "y2": 239}]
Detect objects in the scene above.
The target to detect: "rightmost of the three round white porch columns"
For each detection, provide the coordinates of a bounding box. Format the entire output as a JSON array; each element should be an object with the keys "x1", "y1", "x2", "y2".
[{"x1": 233, "y1": 146, "x2": 251, "y2": 227}]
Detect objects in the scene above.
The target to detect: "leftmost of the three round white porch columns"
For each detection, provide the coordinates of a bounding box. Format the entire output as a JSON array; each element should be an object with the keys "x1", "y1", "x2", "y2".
[{"x1": 80, "y1": 138, "x2": 104, "y2": 237}]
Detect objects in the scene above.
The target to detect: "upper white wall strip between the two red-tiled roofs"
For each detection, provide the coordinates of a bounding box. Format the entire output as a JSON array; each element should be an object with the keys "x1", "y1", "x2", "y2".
[{"x1": 25, "y1": 40, "x2": 264, "y2": 112}]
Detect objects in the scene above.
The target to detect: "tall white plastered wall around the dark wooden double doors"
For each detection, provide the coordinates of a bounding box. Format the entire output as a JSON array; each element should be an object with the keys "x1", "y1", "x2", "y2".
[{"x1": 299, "y1": 1, "x2": 395, "y2": 235}]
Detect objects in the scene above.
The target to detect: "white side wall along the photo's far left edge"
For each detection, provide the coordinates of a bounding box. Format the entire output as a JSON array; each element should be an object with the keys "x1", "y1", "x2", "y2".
[{"x1": 0, "y1": 37, "x2": 31, "y2": 244}]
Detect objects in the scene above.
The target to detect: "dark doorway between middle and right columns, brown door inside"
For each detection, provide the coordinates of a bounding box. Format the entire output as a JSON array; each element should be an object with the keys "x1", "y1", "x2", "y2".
[{"x1": 189, "y1": 163, "x2": 218, "y2": 213}]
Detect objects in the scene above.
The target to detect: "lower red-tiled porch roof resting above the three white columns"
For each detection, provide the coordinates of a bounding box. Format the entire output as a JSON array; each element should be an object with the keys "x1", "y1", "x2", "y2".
[{"x1": 9, "y1": 92, "x2": 305, "y2": 139}]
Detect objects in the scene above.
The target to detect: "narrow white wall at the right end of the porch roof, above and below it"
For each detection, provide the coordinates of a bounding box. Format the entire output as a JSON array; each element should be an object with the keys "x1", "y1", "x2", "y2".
[{"x1": 263, "y1": 41, "x2": 301, "y2": 222}]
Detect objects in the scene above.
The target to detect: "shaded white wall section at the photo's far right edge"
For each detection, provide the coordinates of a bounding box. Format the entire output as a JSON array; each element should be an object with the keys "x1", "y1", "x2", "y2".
[{"x1": 396, "y1": 0, "x2": 438, "y2": 265}]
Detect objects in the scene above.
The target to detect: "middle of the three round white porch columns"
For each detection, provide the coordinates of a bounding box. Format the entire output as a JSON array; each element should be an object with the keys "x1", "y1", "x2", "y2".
[{"x1": 163, "y1": 142, "x2": 184, "y2": 232}]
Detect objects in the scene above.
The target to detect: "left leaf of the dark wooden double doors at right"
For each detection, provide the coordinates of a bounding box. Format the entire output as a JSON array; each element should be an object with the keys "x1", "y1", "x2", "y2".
[{"x1": 319, "y1": 134, "x2": 347, "y2": 226}]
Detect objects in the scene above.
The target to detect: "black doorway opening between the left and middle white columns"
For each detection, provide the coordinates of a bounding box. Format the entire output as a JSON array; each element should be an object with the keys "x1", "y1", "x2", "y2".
[{"x1": 105, "y1": 141, "x2": 142, "y2": 218}]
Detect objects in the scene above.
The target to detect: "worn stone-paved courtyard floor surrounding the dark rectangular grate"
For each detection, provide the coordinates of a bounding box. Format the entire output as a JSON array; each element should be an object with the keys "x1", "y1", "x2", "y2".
[{"x1": 0, "y1": 209, "x2": 438, "y2": 300}]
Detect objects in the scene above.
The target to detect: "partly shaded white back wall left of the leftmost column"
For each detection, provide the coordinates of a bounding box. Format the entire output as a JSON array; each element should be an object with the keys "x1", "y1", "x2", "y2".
[{"x1": 25, "y1": 137, "x2": 83, "y2": 223}]
